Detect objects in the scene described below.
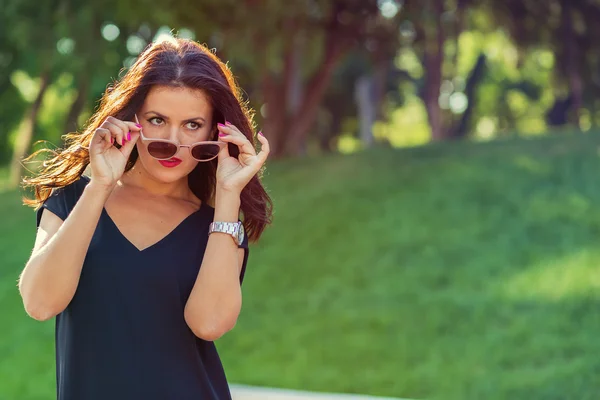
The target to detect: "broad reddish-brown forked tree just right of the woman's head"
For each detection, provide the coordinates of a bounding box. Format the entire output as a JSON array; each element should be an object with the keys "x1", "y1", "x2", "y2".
[{"x1": 171, "y1": 0, "x2": 397, "y2": 157}]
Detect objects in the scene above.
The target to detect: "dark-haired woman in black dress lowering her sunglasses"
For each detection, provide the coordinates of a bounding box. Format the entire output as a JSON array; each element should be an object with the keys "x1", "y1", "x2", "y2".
[{"x1": 19, "y1": 39, "x2": 272, "y2": 400}]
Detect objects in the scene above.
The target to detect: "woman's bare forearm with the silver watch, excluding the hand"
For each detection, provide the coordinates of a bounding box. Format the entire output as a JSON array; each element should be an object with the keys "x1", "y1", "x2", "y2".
[{"x1": 185, "y1": 190, "x2": 245, "y2": 341}]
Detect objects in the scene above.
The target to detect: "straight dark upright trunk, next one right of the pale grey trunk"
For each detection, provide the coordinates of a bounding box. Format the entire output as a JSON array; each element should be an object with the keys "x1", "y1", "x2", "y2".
[{"x1": 424, "y1": 0, "x2": 445, "y2": 141}]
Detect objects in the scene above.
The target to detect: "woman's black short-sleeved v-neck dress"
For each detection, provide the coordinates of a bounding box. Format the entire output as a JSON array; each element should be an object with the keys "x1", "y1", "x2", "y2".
[{"x1": 37, "y1": 176, "x2": 248, "y2": 400}]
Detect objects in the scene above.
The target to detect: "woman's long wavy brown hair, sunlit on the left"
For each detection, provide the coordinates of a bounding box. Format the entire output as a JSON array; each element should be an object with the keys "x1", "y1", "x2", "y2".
[{"x1": 23, "y1": 38, "x2": 273, "y2": 241}]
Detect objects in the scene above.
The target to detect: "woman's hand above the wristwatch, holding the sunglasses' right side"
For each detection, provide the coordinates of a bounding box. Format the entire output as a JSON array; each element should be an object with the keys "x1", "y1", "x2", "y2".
[{"x1": 217, "y1": 122, "x2": 269, "y2": 193}]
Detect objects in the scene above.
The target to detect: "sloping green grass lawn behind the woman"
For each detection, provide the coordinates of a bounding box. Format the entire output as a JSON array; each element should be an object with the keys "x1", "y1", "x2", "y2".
[{"x1": 0, "y1": 134, "x2": 600, "y2": 400}]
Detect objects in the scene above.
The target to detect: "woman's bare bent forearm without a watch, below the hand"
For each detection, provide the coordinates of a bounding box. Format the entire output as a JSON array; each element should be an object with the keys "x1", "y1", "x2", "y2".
[{"x1": 19, "y1": 181, "x2": 110, "y2": 321}]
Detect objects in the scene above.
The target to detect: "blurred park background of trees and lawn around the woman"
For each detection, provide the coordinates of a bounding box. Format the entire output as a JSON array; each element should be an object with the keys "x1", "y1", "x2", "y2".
[{"x1": 0, "y1": 0, "x2": 600, "y2": 400}]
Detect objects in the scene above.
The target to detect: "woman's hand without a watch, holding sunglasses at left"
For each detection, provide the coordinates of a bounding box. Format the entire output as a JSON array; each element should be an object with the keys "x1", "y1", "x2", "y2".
[{"x1": 89, "y1": 117, "x2": 141, "y2": 190}]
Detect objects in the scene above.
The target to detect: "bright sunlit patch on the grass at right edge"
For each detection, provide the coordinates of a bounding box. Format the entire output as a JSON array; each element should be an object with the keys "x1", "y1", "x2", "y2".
[{"x1": 501, "y1": 250, "x2": 600, "y2": 301}]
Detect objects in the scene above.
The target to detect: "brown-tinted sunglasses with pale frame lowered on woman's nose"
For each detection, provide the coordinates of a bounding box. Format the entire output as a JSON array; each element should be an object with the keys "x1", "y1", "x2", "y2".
[{"x1": 134, "y1": 114, "x2": 227, "y2": 162}]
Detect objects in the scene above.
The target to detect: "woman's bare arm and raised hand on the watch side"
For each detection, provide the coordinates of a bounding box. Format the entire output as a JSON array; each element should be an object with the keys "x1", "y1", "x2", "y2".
[{"x1": 184, "y1": 122, "x2": 269, "y2": 340}]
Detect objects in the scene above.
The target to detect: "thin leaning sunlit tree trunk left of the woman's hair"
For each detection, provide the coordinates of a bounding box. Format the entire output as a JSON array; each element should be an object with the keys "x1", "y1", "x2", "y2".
[{"x1": 9, "y1": 67, "x2": 50, "y2": 188}]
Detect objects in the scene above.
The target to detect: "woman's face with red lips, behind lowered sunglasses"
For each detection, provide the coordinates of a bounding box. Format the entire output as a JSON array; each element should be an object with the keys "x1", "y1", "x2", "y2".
[{"x1": 136, "y1": 86, "x2": 215, "y2": 182}]
